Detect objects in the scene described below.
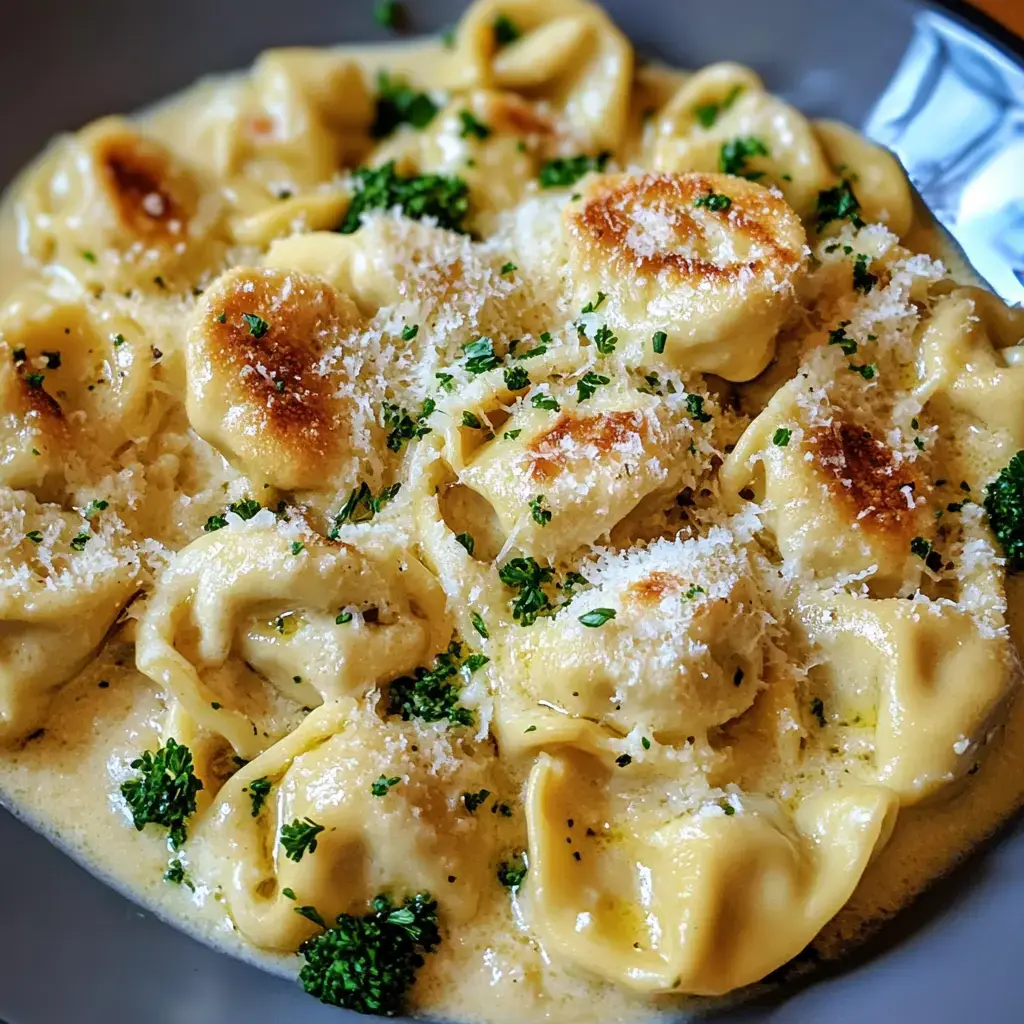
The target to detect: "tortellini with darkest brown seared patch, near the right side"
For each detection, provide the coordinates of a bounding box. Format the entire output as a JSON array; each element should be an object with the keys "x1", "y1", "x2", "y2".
[{"x1": 721, "y1": 376, "x2": 931, "y2": 591}]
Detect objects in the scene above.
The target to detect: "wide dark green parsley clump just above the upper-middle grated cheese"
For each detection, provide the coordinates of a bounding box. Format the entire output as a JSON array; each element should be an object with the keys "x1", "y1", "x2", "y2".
[{"x1": 338, "y1": 160, "x2": 469, "y2": 234}]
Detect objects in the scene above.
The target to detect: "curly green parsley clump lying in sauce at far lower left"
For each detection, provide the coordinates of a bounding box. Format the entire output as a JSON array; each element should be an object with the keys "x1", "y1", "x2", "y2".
[{"x1": 121, "y1": 738, "x2": 203, "y2": 850}]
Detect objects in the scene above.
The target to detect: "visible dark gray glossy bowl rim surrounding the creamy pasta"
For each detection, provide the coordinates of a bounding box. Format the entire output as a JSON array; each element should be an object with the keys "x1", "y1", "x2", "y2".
[{"x1": 0, "y1": 0, "x2": 1024, "y2": 1024}]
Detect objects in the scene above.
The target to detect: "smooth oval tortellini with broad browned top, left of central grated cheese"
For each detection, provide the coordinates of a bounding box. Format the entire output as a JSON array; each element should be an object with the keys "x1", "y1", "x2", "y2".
[{"x1": 186, "y1": 267, "x2": 359, "y2": 489}]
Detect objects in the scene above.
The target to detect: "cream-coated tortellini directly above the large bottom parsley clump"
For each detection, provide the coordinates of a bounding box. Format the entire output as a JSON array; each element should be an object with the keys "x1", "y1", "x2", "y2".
[{"x1": 189, "y1": 700, "x2": 498, "y2": 951}]
